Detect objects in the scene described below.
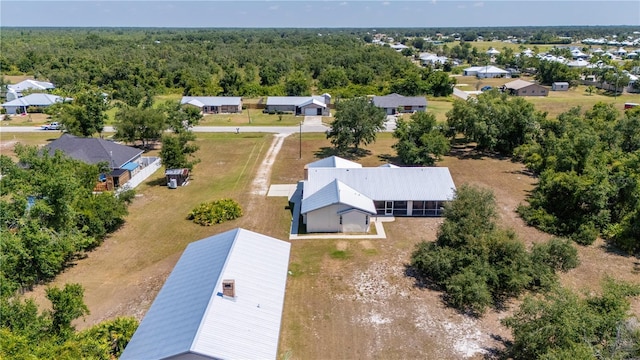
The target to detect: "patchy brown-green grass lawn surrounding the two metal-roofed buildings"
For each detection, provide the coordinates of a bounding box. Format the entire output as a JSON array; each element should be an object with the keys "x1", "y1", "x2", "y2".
[{"x1": 3, "y1": 128, "x2": 640, "y2": 359}]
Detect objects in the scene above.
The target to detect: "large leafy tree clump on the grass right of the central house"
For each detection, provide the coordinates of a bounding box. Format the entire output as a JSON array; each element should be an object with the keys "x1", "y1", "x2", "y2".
[{"x1": 411, "y1": 186, "x2": 578, "y2": 315}]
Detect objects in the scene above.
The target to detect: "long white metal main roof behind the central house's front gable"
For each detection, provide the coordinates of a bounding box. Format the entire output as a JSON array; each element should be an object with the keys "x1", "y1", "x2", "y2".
[{"x1": 303, "y1": 167, "x2": 455, "y2": 201}]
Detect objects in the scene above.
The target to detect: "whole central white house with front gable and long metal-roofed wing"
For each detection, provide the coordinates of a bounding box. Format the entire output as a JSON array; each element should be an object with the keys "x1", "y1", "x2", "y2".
[{"x1": 300, "y1": 157, "x2": 455, "y2": 232}]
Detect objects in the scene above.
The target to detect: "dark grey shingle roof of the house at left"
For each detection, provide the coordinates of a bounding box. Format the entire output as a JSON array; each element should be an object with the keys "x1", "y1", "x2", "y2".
[{"x1": 44, "y1": 134, "x2": 143, "y2": 169}]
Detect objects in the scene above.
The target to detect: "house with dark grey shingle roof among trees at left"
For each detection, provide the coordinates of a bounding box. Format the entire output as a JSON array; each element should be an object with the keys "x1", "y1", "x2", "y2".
[{"x1": 44, "y1": 134, "x2": 148, "y2": 190}]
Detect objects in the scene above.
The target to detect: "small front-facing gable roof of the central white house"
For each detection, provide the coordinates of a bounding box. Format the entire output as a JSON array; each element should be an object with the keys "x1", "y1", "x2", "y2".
[{"x1": 300, "y1": 180, "x2": 376, "y2": 214}]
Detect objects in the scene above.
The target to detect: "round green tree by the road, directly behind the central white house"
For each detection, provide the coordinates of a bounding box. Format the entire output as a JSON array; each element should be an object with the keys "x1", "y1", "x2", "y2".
[{"x1": 327, "y1": 97, "x2": 386, "y2": 152}]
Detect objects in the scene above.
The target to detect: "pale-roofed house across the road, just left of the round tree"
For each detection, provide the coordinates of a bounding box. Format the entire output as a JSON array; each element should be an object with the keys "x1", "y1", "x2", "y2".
[{"x1": 265, "y1": 93, "x2": 331, "y2": 116}]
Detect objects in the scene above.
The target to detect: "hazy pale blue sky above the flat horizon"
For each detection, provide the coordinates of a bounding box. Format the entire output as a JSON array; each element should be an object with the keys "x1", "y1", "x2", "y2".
[{"x1": 0, "y1": 0, "x2": 640, "y2": 27}]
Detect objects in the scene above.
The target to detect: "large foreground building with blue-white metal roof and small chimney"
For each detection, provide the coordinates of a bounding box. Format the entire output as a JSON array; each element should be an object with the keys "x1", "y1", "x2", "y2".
[{"x1": 120, "y1": 229, "x2": 291, "y2": 360}]
